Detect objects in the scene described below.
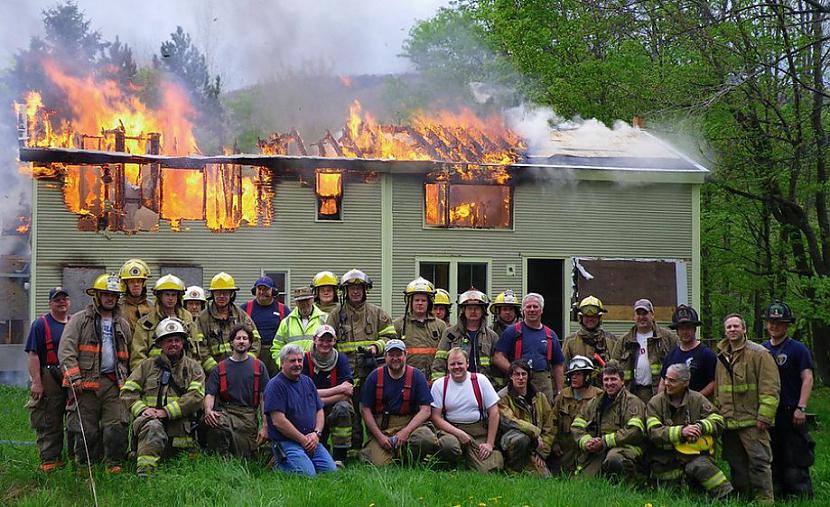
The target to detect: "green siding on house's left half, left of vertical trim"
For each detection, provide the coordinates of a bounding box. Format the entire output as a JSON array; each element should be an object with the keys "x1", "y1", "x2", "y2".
[{"x1": 31, "y1": 180, "x2": 381, "y2": 316}]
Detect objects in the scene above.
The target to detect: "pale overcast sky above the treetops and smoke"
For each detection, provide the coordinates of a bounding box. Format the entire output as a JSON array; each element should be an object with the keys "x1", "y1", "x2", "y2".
[{"x1": 0, "y1": 0, "x2": 449, "y2": 89}]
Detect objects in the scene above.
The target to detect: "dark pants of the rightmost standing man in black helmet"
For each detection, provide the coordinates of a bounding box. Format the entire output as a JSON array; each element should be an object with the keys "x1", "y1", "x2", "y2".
[{"x1": 769, "y1": 406, "x2": 816, "y2": 498}]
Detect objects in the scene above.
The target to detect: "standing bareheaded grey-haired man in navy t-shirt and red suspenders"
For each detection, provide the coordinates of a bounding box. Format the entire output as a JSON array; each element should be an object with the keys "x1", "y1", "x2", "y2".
[{"x1": 493, "y1": 292, "x2": 565, "y2": 403}]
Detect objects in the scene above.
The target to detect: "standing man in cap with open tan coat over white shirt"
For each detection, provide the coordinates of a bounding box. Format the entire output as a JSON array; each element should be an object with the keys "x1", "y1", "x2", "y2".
[{"x1": 611, "y1": 299, "x2": 677, "y2": 403}]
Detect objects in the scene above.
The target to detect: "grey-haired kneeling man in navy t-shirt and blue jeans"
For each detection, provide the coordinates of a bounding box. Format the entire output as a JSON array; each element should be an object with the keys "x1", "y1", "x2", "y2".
[{"x1": 264, "y1": 344, "x2": 337, "y2": 477}]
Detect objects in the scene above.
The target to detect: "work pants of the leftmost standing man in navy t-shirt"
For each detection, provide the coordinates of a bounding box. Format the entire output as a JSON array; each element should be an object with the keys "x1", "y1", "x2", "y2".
[{"x1": 26, "y1": 368, "x2": 67, "y2": 464}]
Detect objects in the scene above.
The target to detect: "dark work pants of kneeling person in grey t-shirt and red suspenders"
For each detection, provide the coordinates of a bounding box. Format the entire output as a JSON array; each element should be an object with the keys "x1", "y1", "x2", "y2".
[{"x1": 202, "y1": 403, "x2": 259, "y2": 458}]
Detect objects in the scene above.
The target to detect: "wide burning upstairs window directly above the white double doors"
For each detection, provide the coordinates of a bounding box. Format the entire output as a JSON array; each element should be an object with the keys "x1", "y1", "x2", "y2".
[{"x1": 424, "y1": 181, "x2": 513, "y2": 229}]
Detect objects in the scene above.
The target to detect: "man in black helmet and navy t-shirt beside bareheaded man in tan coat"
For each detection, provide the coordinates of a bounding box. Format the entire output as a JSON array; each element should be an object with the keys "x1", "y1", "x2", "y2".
[{"x1": 657, "y1": 305, "x2": 718, "y2": 400}]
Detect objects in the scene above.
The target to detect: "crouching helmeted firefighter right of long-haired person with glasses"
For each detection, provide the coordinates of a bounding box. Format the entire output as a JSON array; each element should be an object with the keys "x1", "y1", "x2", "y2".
[{"x1": 549, "y1": 356, "x2": 602, "y2": 474}]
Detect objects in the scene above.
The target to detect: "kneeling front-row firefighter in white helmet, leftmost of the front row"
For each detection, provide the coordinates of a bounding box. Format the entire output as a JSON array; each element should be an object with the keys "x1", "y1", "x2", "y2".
[{"x1": 121, "y1": 317, "x2": 205, "y2": 477}]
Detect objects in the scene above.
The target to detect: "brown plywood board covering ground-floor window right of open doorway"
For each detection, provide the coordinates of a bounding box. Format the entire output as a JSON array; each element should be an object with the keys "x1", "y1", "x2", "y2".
[{"x1": 573, "y1": 258, "x2": 688, "y2": 321}]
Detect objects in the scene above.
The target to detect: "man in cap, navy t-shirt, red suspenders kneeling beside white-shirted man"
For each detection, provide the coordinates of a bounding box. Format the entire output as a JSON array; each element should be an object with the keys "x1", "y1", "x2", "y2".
[{"x1": 360, "y1": 339, "x2": 438, "y2": 466}]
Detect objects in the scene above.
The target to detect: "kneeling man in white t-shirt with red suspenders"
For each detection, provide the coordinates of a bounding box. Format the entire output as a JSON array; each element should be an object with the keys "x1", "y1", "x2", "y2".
[{"x1": 431, "y1": 347, "x2": 504, "y2": 472}]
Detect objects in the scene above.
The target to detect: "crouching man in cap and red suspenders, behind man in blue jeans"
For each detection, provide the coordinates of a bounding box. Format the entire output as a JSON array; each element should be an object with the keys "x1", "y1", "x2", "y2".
[{"x1": 303, "y1": 328, "x2": 355, "y2": 466}]
